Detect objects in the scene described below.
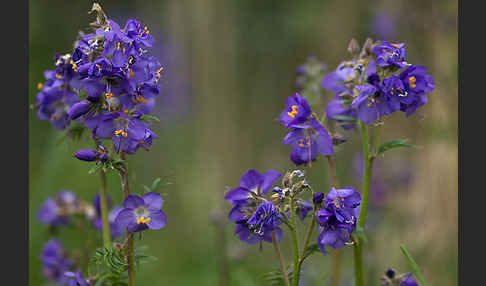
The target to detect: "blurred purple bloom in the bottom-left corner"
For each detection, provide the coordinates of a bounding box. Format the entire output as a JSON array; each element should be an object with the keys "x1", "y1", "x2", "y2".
[{"x1": 40, "y1": 239, "x2": 73, "y2": 284}]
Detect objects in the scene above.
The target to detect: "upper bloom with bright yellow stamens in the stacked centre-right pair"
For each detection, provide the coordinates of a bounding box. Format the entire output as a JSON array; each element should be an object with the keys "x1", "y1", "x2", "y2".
[{"x1": 279, "y1": 93, "x2": 312, "y2": 128}]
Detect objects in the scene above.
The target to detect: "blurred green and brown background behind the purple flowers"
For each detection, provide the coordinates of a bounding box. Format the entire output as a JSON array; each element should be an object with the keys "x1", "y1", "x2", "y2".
[{"x1": 29, "y1": 0, "x2": 458, "y2": 286}]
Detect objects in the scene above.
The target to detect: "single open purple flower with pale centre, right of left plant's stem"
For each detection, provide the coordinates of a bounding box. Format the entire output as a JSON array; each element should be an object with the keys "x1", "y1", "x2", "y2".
[{"x1": 115, "y1": 192, "x2": 167, "y2": 232}]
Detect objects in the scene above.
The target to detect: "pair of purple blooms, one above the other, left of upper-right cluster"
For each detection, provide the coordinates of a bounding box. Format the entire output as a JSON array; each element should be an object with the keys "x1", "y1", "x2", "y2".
[{"x1": 279, "y1": 93, "x2": 334, "y2": 166}]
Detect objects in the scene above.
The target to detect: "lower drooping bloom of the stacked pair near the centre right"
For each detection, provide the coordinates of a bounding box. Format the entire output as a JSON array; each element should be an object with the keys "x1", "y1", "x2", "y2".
[{"x1": 283, "y1": 118, "x2": 334, "y2": 166}]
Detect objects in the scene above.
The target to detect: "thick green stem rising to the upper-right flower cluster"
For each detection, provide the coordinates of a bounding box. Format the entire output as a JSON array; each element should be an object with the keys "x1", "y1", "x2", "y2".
[{"x1": 354, "y1": 121, "x2": 374, "y2": 286}]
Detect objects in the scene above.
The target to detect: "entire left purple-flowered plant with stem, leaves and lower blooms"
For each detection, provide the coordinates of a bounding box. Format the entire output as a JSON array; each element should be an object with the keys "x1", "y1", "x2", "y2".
[{"x1": 35, "y1": 3, "x2": 166, "y2": 286}]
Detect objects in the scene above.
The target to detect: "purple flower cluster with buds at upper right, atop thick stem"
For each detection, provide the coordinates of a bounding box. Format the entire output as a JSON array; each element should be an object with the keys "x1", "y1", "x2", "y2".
[{"x1": 322, "y1": 41, "x2": 435, "y2": 126}]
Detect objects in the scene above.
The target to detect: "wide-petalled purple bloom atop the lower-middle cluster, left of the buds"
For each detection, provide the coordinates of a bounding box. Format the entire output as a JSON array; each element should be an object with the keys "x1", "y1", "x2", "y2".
[{"x1": 225, "y1": 170, "x2": 281, "y2": 206}]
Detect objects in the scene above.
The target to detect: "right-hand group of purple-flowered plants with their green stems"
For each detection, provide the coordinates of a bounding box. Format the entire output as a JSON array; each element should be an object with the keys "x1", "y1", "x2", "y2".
[{"x1": 225, "y1": 39, "x2": 434, "y2": 286}]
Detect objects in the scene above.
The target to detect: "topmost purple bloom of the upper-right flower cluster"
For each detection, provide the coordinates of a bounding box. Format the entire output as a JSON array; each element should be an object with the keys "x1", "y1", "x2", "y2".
[{"x1": 373, "y1": 41, "x2": 408, "y2": 68}]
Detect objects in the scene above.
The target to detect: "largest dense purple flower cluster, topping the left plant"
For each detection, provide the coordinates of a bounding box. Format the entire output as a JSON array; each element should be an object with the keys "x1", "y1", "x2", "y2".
[{"x1": 36, "y1": 13, "x2": 162, "y2": 155}]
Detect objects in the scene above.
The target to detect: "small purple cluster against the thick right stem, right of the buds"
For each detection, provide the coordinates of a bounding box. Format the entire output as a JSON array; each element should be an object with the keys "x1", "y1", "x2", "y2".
[{"x1": 313, "y1": 188, "x2": 361, "y2": 254}]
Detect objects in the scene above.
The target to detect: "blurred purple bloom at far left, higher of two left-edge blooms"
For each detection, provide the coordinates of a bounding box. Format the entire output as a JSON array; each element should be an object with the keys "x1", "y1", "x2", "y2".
[{"x1": 37, "y1": 191, "x2": 79, "y2": 227}]
